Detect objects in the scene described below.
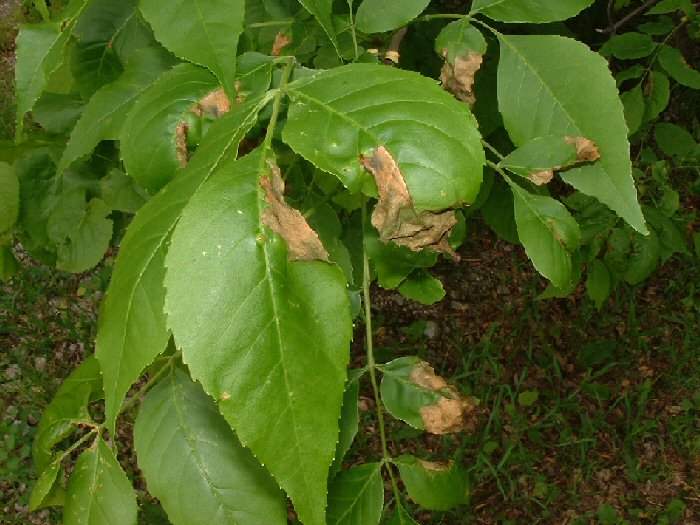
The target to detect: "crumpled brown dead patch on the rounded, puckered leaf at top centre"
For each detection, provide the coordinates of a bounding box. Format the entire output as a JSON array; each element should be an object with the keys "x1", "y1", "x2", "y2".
[{"x1": 360, "y1": 146, "x2": 459, "y2": 260}]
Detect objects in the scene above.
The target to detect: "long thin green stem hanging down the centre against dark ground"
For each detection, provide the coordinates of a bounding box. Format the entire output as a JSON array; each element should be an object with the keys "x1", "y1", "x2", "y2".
[{"x1": 362, "y1": 198, "x2": 400, "y2": 501}]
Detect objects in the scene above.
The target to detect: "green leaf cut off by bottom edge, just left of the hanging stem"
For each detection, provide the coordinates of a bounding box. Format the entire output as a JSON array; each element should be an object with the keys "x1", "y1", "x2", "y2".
[{"x1": 328, "y1": 463, "x2": 384, "y2": 525}]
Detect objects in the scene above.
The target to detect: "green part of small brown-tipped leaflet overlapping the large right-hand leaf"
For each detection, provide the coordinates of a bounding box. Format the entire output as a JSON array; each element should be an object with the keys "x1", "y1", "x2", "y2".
[{"x1": 499, "y1": 136, "x2": 576, "y2": 178}]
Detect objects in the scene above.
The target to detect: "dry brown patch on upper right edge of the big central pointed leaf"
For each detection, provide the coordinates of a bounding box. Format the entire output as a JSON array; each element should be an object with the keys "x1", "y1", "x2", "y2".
[{"x1": 260, "y1": 162, "x2": 329, "y2": 262}]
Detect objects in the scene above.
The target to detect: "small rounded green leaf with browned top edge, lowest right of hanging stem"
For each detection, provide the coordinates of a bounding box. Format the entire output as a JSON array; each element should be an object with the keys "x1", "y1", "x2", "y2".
[{"x1": 394, "y1": 454, "x2": 470, "y2": 510}]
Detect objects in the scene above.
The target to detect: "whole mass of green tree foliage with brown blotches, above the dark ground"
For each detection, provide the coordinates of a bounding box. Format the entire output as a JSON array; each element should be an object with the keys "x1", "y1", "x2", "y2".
[{"x1": 8, "y1": 0, "x2": 695, "y2": 525}]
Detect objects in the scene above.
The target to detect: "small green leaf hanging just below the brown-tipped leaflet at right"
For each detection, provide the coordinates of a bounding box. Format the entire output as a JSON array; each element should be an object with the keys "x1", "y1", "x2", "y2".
[{"x1": 508, "y1": 180, "x2": 581, "y2": 288}]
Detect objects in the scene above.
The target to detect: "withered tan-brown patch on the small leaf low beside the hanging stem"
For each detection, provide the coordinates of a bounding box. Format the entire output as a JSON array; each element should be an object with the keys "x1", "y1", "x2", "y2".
[{"x1": 409, "y1": 361, "x2": 478, "y2": 434}]
